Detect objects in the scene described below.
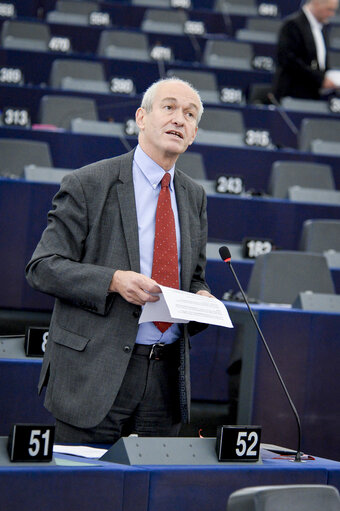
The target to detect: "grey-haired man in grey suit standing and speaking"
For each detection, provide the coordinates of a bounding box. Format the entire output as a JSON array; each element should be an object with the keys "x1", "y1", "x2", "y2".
[{"x1": 26, "y1": 79, "x2": 211, "y2": 443}]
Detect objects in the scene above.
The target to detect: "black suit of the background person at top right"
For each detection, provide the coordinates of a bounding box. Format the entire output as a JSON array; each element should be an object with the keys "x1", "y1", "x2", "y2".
[{"x1": 273, "y1": 0, "x2": 337, "y2": 100}]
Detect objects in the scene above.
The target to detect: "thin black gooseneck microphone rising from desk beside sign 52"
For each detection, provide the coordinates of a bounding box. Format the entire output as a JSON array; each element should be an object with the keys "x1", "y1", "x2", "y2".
[{"x1": 219, "y1": 246, "x2": 301, "y2": 461}]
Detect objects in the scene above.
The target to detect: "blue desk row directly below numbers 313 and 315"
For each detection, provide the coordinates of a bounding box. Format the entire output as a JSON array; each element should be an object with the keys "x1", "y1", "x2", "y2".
[{"x1": 0, "y1": 127, "x2": 340, "y2": 191}]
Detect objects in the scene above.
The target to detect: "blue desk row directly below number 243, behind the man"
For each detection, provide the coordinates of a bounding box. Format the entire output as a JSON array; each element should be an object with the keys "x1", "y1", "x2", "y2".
[{"x1": 0, "y1": 179, "x2": 340, "y2": 310}]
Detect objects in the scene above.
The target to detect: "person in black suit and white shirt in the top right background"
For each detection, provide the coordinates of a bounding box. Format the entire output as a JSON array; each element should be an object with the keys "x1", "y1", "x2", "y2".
[{"x1": 273, "y1": 0, "x2": 339, "y2": 100}]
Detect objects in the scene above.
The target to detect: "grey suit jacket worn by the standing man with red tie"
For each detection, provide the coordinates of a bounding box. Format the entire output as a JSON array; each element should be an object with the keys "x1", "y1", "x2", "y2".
[{"x1": 26, "y1": 151, "x2": 209, "y2": 428}]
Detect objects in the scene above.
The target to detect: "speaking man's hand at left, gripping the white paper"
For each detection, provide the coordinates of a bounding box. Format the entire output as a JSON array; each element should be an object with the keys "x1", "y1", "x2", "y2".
[{"x1": 109, "y1": 270, "x2": 161, "y2": 305}]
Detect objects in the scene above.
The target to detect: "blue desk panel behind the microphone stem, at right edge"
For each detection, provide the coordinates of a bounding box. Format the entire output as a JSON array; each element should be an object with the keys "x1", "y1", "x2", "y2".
[{"x1": 228, "y1": 302, "x2": 340, "y2": 460}]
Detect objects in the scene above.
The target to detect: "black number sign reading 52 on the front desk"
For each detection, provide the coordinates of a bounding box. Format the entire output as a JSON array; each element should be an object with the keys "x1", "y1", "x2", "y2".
[{"x1": 216, "y1": 426, "x2": 261, "y2": 462}]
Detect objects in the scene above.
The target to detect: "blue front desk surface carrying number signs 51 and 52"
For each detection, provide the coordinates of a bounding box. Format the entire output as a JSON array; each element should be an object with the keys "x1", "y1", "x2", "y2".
[{"x1": 0, "y1": 438, "x2": 340, "y2": 511}]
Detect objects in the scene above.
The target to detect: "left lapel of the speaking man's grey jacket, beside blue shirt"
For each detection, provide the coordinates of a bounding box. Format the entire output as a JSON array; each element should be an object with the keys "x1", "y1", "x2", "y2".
[{"x1": 117, "y1": 151, "x2": 140, "y2": 273}]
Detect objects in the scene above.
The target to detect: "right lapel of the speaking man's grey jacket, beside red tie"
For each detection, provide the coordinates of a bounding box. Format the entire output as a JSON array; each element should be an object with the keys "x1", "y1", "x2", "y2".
[{"x1": 174, "y1": 171, "x2": 191, "y2": 291}]
